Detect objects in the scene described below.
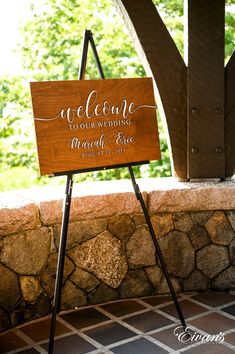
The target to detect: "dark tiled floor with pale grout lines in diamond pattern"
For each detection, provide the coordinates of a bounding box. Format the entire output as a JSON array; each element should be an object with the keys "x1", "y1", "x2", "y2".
[{"x1": 0, "y1": 291, "x2": 235, "y2": 354}]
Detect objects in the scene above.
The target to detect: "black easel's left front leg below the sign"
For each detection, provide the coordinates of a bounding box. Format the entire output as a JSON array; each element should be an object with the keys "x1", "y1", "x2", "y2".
[{"x1": 48, "y1": 175, "x2": 73, "y2": 354}]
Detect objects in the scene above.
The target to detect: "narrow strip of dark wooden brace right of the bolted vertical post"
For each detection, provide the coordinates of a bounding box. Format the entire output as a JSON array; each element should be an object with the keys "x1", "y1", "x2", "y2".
[{"x1": 225, "y1": 52, "x2": 235, "y2": 177}]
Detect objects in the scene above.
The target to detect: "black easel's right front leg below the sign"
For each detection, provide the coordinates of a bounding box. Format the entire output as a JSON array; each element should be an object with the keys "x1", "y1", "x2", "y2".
[{"x1": 128, "y1": 166, "x2": 186, "y2": 328}]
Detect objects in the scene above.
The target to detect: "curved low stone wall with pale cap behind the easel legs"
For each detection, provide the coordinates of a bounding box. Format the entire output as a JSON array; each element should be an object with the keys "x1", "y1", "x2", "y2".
[{"x1": 0, "y1": 178, "x2": 235, "y2": 330}]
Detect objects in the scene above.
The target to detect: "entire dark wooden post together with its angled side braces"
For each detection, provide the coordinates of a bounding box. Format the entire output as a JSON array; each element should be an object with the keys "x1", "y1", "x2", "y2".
[{"x1": 114, "y1": 0, "x2": 235, "y2": 180}]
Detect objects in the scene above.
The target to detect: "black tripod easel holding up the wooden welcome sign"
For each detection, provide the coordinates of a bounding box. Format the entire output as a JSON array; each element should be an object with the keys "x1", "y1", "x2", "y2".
[{"x1": 48, "y1": 30, "x2": 186, "y2": 354}]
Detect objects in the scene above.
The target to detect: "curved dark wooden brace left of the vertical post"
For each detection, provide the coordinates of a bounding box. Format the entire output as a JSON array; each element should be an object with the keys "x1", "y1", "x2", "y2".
[{"x1": 114, "y1": 0, "x2": 187, "y2": 179}]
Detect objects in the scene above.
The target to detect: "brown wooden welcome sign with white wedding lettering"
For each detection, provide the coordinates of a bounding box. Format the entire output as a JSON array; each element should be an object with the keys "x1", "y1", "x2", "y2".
[{"x1": 30, "y1": 78, "x2": 160, "y2": 175}]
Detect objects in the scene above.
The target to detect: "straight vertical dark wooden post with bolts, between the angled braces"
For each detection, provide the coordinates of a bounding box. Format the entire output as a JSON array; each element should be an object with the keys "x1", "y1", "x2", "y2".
[{"x1": 188, "y1": 0, "x2": 225, "y2": 179}]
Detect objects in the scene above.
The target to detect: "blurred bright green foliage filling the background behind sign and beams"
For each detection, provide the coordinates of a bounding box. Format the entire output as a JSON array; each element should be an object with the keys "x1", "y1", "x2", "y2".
[{"x1": 0, "y1": 0, "x2": 235, "y2": 191}]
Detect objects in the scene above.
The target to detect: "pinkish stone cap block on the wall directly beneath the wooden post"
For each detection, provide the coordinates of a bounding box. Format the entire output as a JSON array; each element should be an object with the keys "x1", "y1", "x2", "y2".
[{"x1": 147, "y1": 178, "x2": 235, "y2": 213}]
